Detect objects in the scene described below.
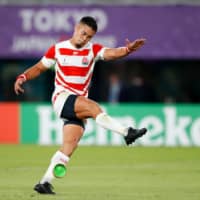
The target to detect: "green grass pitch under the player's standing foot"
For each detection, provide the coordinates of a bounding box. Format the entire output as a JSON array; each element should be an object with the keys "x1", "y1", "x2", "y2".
[{"x1": 0, "y1": 145, "x2": 200, "y2": 200}]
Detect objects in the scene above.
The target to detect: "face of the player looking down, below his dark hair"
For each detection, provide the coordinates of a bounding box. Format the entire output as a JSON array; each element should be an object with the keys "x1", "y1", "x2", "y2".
[{"x1": 73, "y1": 23, "x2": 96, "y2": 48}]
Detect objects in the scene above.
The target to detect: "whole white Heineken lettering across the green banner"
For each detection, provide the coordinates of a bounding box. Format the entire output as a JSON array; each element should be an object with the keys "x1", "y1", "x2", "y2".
[{"x1": 37, "y1": 106, "x2": 200, "y2": 146}]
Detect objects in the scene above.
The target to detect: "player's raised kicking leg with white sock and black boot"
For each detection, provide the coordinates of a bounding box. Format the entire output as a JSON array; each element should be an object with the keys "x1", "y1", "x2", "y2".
[{"x1": 75, "y1": 96, "x2": 147, "y2": 145}]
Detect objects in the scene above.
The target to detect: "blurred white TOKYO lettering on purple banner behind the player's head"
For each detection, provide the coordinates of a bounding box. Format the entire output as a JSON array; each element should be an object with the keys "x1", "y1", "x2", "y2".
[{"x1": 19, "y1": 9, "x2": 108, "y2": 32}]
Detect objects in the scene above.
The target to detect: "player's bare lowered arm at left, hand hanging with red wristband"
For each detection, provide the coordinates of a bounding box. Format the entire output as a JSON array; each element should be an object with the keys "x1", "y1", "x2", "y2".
[{"x1": 14, "y1": 61, "x2": 47, "y2": 95}]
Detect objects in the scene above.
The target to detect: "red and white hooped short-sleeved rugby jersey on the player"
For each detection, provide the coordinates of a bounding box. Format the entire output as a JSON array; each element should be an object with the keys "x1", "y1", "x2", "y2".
[{"x1": 41, "y1": 40, "x2": 105, "y2": 99}]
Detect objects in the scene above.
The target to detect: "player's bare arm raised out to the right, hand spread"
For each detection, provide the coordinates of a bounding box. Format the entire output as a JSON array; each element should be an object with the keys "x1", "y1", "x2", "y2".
[{"x1": 104, "y1": 38, "x2": 146, "y2": 60}]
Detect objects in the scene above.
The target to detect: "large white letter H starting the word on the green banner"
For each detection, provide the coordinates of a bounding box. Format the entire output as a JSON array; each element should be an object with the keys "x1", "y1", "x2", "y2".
[{"x1": 37, "y1": 106, "x2": 63, "y2": 145}]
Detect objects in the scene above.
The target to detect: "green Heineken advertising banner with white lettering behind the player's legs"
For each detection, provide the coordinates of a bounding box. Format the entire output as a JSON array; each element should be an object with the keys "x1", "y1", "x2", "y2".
[{"x1": 21, "y1": 104, "x2": 200, "y2": 146}]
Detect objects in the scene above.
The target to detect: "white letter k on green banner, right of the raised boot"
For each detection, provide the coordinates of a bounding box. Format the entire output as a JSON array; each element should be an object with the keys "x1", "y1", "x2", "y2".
[{"x1": 164, "y1": 107, "x2": 192, "y2": 146}]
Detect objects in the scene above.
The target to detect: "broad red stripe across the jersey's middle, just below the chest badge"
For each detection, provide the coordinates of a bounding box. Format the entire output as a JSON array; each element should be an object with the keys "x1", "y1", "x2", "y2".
[{"x1": 57, "y1": 59, "x2": 93, "y2": 76}]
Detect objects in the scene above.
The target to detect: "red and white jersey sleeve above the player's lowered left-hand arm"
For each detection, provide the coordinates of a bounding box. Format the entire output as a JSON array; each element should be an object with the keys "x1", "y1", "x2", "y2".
[{"x1": 41, "y1": 45, "x2": 56, "y2": 68}]
